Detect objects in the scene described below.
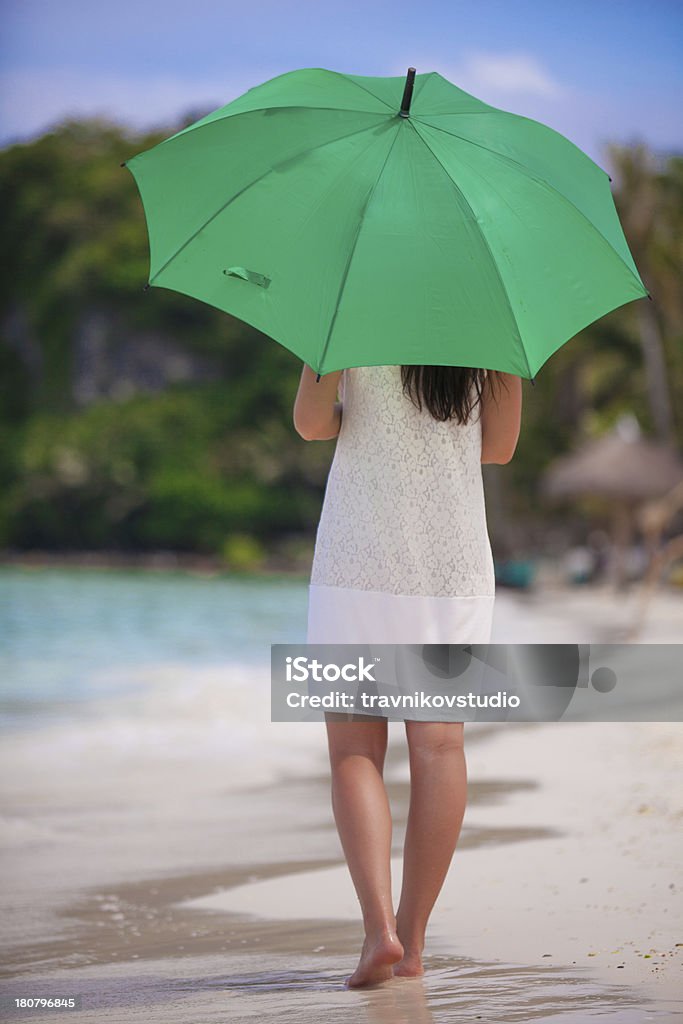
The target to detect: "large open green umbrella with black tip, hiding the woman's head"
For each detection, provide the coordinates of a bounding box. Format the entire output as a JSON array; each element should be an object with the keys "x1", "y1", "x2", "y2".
[{"x1": 124, "y1": 68, "x2": 648, "y2": 379}]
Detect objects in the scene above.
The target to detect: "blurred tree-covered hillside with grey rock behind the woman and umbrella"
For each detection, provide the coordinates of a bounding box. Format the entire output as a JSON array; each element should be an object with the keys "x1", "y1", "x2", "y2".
[{"x1": 0, "y1": 112, "x2": 683, "y2": 567}]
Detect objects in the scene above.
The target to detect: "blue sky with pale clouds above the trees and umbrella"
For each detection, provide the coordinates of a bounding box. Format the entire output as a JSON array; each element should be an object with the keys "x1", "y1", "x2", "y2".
[{"x1": 0, "y1": 0, "x2": 683, "y2": 171}]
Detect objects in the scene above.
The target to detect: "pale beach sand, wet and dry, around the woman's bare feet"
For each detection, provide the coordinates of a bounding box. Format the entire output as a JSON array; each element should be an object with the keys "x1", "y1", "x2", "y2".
[{"x1": 0, "y1": 723, "x2": 683, "y2": 1024}]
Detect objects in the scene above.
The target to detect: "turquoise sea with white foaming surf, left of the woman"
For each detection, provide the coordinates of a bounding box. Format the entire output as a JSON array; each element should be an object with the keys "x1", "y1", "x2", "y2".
[{"x1": 0, "y1": 566, "x2": 333, "y2": 819}]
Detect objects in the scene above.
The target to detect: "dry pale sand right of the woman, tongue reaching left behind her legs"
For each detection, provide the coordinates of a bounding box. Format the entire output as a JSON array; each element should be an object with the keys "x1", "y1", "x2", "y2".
[{"x1": 179, "y1": 723, "x2": 683, "y2": 1011}]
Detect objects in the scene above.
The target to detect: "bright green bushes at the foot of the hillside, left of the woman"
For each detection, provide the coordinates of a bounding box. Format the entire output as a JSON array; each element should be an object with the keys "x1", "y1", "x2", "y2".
[{"x1": 0, "y1": 384, "x2": 321, "y2": 552}]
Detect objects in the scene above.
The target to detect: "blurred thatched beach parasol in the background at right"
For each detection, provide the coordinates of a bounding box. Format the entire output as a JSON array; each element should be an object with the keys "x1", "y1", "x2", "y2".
[{"x1": 541, "y1": 416, "x2": 683, "y2": 585}]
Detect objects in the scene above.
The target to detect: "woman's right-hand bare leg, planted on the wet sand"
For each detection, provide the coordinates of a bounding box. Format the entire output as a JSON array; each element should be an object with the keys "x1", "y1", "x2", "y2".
[{"x1": 393, "y1": 722, "x2": 467, "y2": 976}]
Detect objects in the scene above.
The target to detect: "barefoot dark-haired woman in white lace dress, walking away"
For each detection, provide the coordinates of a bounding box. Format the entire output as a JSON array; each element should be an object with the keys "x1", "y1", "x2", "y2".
[{"x1": 294, "y1": 366, "x2": 521, "y2": 986}]
